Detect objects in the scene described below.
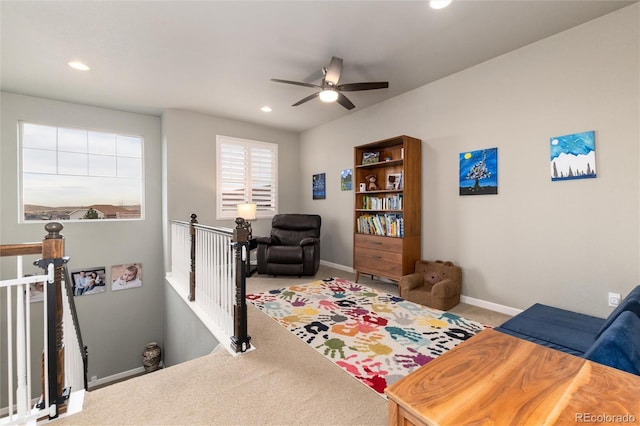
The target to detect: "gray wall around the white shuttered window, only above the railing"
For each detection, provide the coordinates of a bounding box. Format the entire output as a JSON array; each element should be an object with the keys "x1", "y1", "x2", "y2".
[{"x1": 162, "y1": 109, "x2": 300, "y2": 264}]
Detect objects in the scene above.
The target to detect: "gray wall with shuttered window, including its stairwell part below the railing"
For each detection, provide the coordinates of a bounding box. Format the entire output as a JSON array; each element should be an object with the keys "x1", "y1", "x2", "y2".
[{"x1": 162, "y1": 110, "x2": 300, "y2": 365}]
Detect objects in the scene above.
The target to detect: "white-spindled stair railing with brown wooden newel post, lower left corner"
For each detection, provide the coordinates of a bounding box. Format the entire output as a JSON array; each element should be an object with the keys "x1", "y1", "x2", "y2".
[{"x1": 0, "y1": 222, "x2": 87, "y2": 426}]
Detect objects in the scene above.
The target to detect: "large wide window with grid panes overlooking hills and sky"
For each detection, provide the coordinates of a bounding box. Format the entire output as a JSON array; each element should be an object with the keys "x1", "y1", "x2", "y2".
[{"x1": 19, "y1": 122, "x2": 144, "y2": 221}]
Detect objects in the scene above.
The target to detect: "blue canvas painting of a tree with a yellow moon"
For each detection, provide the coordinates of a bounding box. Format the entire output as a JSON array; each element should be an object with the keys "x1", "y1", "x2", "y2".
[{"x1": 459, "y1": 148, "x2": 498, "y2": 195}]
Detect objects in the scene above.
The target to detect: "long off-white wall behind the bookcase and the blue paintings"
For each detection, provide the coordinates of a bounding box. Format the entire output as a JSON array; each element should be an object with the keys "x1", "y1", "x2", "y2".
[{"x1": 300, "y1": 4, "x2": 640, "y2": 316}]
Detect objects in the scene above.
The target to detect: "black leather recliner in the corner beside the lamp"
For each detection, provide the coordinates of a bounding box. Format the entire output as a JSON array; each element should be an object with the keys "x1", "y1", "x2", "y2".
[{"x1": 256, "y1": 214, "x2": 322, "y2": 276}]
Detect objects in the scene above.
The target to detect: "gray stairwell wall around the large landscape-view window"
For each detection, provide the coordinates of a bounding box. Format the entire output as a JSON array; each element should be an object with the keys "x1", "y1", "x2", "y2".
[{"x1": 0, "y1": 92, "x2": 164, "y2": 389}]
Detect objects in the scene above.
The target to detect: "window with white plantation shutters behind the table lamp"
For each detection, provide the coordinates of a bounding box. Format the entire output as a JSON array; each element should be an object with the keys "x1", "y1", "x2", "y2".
[{"x1": 216, "y1": 135, "x2": 278, "y2": 220}]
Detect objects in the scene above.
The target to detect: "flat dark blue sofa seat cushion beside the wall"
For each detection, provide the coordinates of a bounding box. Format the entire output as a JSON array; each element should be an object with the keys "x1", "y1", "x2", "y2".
[{"x1": 497, "y1": 303, "x2": 605, "y2": 355}]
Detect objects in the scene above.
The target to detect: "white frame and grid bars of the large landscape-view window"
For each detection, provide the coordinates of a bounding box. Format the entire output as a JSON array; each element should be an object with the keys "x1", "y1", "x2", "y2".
[{"x1": 17, "y1": 120, "x2": 146, "y2": 224}]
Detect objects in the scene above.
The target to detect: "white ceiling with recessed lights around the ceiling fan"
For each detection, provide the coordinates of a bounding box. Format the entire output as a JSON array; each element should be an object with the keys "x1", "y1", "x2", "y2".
[{"x1": 0, "y1": 0, "x2": 636, "y2": 131}]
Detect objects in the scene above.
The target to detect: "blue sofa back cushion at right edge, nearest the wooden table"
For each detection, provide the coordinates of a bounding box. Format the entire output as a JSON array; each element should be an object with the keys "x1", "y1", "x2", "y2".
[{"x1": 584, "y1": 311, "x2": 640, "y2": 375}]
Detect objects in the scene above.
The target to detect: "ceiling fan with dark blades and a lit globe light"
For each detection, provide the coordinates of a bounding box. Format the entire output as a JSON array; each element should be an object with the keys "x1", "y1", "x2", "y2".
[{"x1": 271, "y1": 56, "x2": 389, "y2": 109}]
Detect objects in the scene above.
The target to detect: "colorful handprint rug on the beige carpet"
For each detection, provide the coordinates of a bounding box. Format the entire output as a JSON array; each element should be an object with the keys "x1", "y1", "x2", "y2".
[{"x1": 247, "y1": 278, "x2": 486, "y2": 398}]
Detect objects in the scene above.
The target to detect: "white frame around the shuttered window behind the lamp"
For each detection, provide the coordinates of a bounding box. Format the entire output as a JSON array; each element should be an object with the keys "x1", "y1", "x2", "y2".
[{"x1": 216, "y1": 135, "x2": 278, "y2": 220}]
